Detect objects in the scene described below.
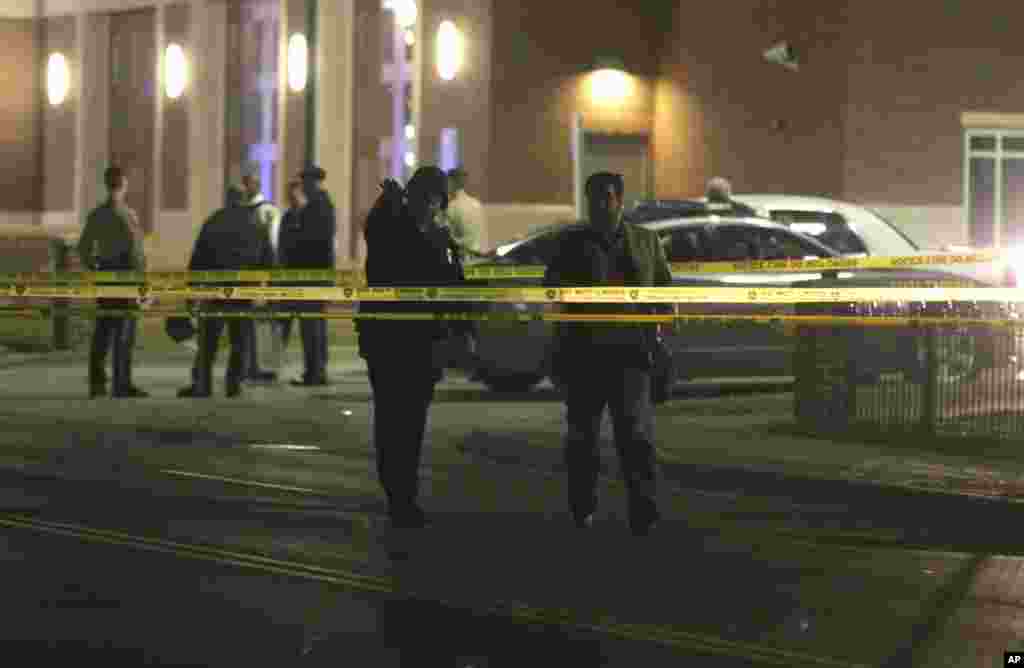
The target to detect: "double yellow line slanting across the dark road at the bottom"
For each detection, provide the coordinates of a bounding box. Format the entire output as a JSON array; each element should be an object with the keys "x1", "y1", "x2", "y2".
[{"x1": 0, "y1": 514, "x2": 867, "y2": 668}]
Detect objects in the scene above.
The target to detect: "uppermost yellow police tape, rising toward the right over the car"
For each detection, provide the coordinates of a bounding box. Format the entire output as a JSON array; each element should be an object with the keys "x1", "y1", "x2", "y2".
[{"x1": 0, "y1": 250, "x2": 1006, "y2": 287}]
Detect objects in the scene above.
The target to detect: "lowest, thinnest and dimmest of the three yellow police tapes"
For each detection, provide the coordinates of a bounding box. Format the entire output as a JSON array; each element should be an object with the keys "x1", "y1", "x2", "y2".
[{"x1": 0, "y1": 306, "x2": 1024, "y2": 328}]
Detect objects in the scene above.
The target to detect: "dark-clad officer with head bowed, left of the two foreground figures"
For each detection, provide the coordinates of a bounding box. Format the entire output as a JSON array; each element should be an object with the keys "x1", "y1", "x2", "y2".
[{"x1": 356, "y1": 167, "x2": 472, "y2": 529}]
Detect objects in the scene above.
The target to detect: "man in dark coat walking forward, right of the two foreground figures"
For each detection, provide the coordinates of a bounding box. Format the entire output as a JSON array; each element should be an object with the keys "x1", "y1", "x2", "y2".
[{"x1": 545, "y1": 172, "x2": 672, "y2": 535}]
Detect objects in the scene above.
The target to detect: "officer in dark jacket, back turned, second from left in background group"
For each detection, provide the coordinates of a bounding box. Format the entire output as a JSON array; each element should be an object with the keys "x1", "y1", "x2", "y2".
[{"x1": 178, "y1": 185, "x2": 273, "y2": 398}]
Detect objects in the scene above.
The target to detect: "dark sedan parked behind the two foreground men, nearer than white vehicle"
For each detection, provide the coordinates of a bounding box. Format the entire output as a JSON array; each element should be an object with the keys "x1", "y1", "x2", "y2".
[{"x1": 466, "y1": 211, "x2": 1009, "y2": 391}]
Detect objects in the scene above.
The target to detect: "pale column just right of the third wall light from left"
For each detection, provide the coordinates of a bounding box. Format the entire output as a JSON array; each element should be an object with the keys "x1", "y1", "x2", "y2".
[{"x1": 312, "y1": 0, "x2": 355, "y2": 266}]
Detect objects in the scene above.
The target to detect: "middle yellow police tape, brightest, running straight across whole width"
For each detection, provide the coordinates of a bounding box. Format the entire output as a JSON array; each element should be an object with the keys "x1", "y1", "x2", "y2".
[{"x1": 6, "y1": 285, "x2": 1024, "y2": 304}]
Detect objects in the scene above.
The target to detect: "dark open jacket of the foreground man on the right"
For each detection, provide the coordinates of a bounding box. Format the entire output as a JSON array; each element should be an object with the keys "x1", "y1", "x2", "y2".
[{"x1": 544, "y1": 223, "x2": 673, "y2": 366}]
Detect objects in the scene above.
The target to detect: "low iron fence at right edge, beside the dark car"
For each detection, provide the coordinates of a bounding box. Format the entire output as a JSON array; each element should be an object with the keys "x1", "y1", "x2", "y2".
[{"x1": 794, "y1": 304, "x2": 1024, "y2": 439}]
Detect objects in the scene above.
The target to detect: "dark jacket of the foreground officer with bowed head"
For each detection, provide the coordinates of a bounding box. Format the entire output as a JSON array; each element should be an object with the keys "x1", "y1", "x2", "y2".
[{"x1": 356, "y1": 191, "x2": 471, "y2": 359}]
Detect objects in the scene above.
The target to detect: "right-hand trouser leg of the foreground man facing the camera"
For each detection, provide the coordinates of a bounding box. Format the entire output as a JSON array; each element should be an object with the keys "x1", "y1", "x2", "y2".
[{"x1": 608, "y1": 369, "x2": 657, "y2": 524}]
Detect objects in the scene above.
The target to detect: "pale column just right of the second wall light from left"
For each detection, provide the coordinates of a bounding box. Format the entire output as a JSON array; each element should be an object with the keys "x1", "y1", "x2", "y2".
[{"x1": 188, "y1": 0, "x2": 227, "y2": 236}]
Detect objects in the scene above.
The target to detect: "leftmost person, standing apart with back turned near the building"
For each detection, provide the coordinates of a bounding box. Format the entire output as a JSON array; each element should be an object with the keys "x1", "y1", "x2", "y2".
[{"x1": 78, "y1": 166, "x2": 148, "y2": 399}]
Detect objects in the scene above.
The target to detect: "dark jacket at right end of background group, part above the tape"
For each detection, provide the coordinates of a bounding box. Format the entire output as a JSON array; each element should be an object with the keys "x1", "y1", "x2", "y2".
[{"x1": 278, "y1": 191, "x2": 337, "y2": 269}]
